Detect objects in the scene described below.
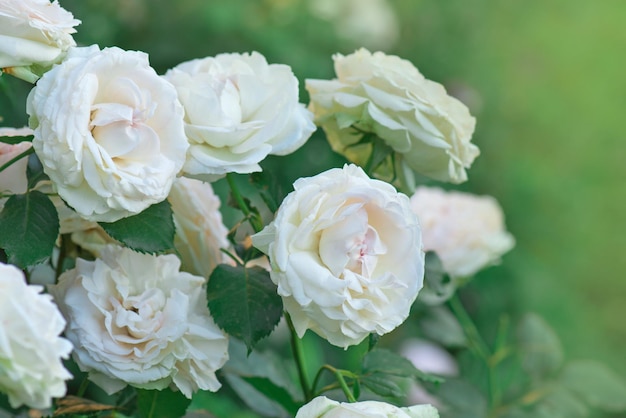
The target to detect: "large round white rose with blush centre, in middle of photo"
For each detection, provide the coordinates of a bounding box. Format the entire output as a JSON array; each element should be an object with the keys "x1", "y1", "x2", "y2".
[{"x1": 252, "y1": 165, "x2": 424, "y2": 348}]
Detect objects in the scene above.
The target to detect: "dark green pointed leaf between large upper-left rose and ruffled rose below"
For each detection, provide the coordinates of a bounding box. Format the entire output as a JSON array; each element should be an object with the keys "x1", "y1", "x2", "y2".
[{"x1": 100, "y1": 200, "x2": 175, "y2": 254}]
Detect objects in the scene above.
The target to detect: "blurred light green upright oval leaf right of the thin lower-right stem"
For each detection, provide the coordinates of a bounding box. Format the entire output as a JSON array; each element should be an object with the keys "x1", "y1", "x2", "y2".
[{"x1": 517, "y1": 314, "x2": 563, "y2": 379}]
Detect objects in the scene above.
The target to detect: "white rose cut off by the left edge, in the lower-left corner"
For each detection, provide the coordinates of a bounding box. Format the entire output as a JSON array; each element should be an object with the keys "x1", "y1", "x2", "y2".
[{"x1": 0, "y1": 263, "x2": 72, "y2": 409}]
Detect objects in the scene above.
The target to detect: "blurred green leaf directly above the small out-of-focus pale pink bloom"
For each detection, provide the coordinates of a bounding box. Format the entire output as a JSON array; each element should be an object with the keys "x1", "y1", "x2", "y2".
[{"x1": 419, "y1": 306, "x2": 467, "y2": 347}]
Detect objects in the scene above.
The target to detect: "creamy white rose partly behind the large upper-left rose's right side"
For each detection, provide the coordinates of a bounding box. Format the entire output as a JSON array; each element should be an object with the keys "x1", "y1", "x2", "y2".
[{"x1": 165, "y1": 52, "x2": 315, "y2": 180}]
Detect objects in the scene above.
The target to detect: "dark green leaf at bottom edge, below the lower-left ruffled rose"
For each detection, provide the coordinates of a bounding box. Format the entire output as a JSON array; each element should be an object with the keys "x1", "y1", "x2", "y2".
[{"x1": 137, "y1": 388, "x2": 191, "y2": 418}]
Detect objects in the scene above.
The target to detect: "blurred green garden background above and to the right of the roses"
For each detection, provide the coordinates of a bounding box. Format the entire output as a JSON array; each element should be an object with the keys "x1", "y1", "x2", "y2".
[{"x1": 0, "y1": 0, "x2": 626, "y2": 412}]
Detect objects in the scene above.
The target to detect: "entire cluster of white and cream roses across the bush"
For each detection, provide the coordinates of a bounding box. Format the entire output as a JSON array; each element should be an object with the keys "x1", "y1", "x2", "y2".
[{"x1": 0, "y1": 0, "x2": 513, "y2": 417}]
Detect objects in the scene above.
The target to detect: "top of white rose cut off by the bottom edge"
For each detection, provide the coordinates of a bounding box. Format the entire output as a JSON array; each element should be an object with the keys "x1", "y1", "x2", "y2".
[{"x1": 296, "y1": 396, "x2": 439, "y2": 418}]
